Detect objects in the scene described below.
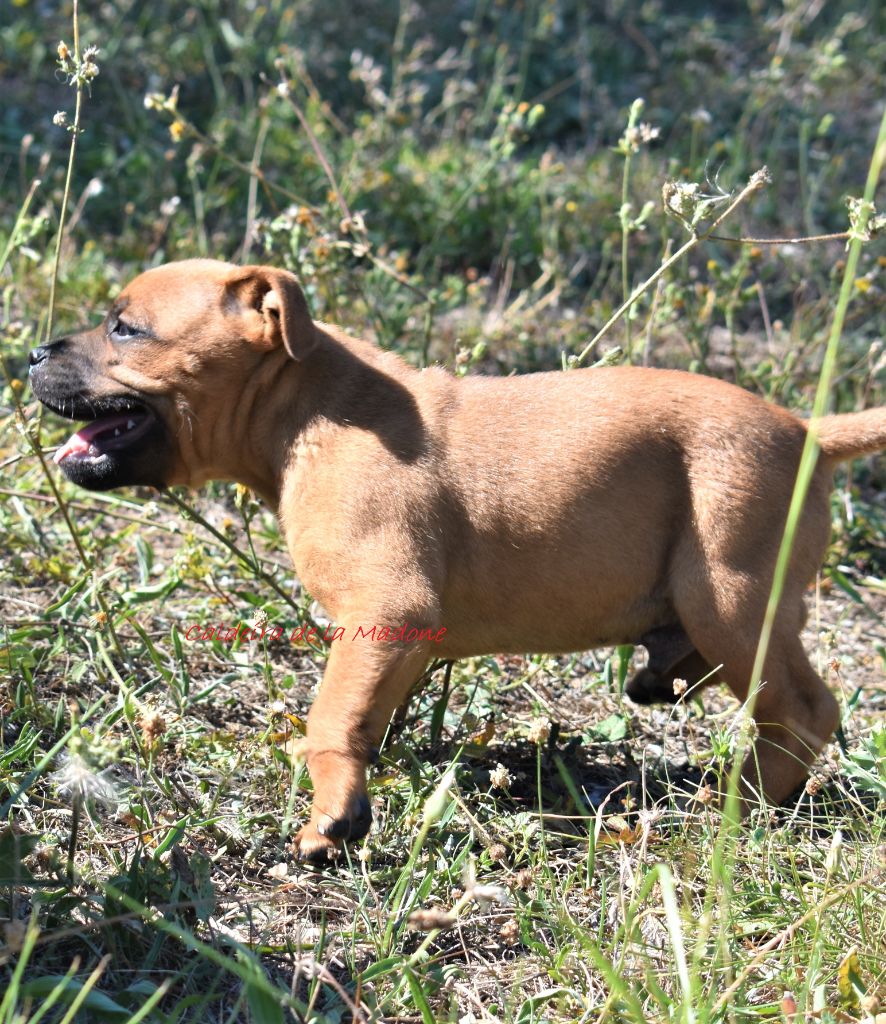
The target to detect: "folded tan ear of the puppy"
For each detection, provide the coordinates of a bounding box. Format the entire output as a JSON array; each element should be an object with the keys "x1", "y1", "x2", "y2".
[{"x1": 225, "y1": 266, "x2": 317, "y2": 360}]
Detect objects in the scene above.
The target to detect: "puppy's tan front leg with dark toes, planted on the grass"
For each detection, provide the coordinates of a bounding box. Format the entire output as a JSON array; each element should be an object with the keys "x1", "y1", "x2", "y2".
[{"x1": 295, "y1": 630, "x2": 429, "y2": 860}]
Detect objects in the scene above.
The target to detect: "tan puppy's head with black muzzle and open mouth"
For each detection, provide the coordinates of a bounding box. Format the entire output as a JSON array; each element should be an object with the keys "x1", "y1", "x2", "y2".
[{"x1": 30, "y1": 260, "x2": 314, "y2": 490}]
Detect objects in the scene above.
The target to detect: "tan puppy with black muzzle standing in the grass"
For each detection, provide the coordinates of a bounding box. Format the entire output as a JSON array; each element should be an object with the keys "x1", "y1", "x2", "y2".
[{"x1": 31, "y1": 260, "x2": 886, "y2": 857}]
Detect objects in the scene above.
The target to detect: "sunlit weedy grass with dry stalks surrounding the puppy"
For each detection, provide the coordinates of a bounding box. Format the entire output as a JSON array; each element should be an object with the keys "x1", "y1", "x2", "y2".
[{"x1": 0, "y1": 0, "x2": 886, "y2": 1024}]
